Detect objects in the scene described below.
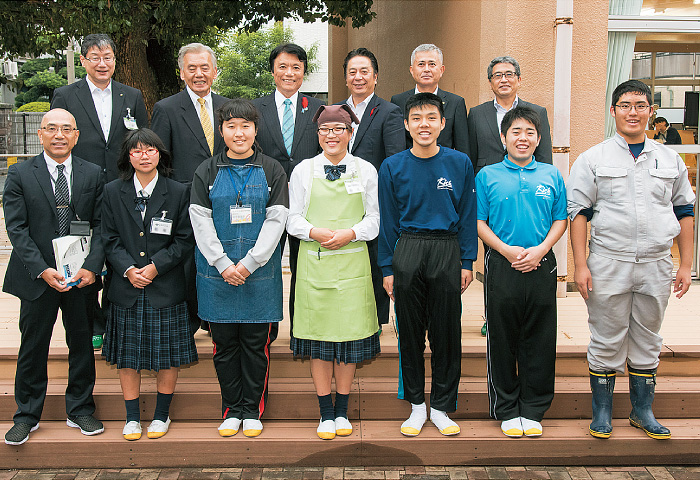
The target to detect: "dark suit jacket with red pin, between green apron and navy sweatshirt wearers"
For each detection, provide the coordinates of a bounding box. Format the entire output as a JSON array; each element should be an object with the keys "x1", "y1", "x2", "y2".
[{"x1": 338, "y1": 94, "x2": 406, "y2": 171}]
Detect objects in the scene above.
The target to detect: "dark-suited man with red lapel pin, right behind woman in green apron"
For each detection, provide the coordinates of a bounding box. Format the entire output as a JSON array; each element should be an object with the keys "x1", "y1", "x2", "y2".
[{"x1": 343, "y1": 47, "x2": 406, "y2": 324}]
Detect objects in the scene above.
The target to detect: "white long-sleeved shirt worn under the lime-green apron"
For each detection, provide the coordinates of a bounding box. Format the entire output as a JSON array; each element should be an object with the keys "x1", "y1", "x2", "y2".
[{"x1": 287, "y1": 153, "x2": 379, "y2": 242}]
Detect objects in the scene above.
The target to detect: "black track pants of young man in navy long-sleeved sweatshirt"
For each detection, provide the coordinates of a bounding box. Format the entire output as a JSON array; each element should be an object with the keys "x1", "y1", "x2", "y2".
[{"x1": 392, "y1": 233, "x2": 462, "y2": 412}]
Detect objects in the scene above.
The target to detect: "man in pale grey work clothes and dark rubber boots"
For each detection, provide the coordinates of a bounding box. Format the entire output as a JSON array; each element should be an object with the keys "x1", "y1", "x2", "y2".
[{"x1": 566, "y1": 80, "x2": 695, "y2": 439}]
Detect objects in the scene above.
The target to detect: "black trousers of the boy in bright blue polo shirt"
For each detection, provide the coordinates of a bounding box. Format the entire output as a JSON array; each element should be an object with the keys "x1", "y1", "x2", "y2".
[{"x1": 484, "y1": 249, "x2": 557, "y2": 422}]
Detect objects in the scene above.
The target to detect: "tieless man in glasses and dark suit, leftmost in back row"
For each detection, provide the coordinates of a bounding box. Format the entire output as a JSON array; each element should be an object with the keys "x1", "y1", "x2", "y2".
[{"x1": 51, "y1": 33, "x2": 148, "y2": 349}]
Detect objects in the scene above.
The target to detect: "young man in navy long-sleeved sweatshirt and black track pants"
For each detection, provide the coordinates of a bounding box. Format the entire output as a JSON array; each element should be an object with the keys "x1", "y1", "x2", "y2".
[{"x1": 378, "y1": 93, "x2": 477, "y2": 436}]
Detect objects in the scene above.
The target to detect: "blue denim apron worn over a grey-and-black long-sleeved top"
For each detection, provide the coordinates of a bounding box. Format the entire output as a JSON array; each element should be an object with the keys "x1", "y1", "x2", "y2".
[{"x1": 195, "y1": 164, "x2": 282, "y2": 323}]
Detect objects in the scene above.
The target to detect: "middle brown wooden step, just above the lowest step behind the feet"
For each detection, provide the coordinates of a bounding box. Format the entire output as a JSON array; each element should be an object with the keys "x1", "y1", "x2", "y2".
[{"x1": 0, "y1": 377, "x2": 700, "y2": 421}]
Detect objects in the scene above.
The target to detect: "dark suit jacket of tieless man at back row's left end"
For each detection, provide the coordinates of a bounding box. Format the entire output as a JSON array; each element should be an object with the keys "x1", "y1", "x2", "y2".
[{"x1": 51, "y1": 79, "x2": 148, "y2": 182}]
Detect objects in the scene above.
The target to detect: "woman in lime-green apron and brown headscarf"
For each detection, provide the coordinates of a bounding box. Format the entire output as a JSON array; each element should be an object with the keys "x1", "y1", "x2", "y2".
[{"x1": 287, "y1": 105, "x2": 379, "y2": 440}]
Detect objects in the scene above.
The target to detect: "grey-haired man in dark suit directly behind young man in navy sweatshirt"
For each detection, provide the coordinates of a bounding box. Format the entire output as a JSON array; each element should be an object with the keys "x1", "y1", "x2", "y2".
[{"x1": 391, "y1": 43, "x2": 469, "y2": 155}]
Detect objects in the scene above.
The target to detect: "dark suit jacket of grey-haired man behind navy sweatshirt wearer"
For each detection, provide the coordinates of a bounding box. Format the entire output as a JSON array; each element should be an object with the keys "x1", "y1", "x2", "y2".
[{"x1": 391, "y1": 88, "x2": 471, "y2": 154}]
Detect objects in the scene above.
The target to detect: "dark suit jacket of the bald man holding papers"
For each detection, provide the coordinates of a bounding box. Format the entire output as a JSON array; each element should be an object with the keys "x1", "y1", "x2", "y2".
[{"x1": 2, "y1": 153, "x2": 104, "y2": 301}]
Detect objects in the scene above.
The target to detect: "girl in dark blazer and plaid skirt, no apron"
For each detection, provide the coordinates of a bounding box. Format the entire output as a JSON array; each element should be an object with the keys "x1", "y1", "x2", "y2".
[{"x1": 102, "y1": 128, "x2": 197, "y2": 440}]
